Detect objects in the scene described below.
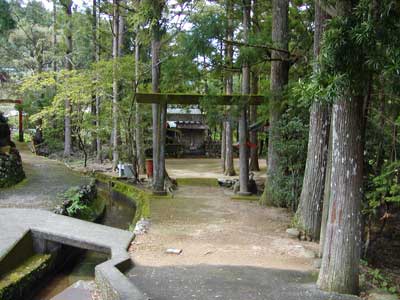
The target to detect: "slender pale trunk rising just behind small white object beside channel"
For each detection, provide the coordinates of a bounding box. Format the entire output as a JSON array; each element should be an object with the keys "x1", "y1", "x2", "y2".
[{"x1": 112, "y1": 0, "x2": 120, "y2": 170}]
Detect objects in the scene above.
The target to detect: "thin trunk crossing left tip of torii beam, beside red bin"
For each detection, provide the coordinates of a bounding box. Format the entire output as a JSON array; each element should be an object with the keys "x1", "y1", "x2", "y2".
[{"x1": 135, "y1": 29, "x2": 146, "y2": 174}]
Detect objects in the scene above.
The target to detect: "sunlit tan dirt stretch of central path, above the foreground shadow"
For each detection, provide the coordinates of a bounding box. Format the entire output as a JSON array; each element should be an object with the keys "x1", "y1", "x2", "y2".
[{"x1": 131, "y1": 186, "x2": 317, "y2": 271}]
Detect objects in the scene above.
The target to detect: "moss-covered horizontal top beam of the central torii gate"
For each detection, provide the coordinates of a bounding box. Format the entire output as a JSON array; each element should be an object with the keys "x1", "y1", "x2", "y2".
[{"x1": 136, "y1": 93, "x2": 265, "y2": 193}]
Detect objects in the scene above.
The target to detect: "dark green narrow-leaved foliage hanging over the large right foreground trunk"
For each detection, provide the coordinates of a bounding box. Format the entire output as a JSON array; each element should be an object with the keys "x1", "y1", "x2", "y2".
[{"x1": 310, "y1": 0, "x2": 400, "y2": 102}]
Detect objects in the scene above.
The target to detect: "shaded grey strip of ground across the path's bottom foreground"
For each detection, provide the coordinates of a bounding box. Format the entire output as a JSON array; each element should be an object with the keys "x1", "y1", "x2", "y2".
[{"x1": 128, "y1": 265, "x2": 358, "y2": 300}]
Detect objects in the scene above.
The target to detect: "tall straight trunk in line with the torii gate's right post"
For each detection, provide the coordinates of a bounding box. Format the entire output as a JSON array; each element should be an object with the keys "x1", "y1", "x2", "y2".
[{"x1": 239, "y1": 0, "x2": 251, "y2": 195}]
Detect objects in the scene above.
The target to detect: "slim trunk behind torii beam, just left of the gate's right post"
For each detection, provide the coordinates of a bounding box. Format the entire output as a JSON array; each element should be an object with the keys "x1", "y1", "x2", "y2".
[{"x1": 225, "y1": 0, "x2": 236, "y2": 176}]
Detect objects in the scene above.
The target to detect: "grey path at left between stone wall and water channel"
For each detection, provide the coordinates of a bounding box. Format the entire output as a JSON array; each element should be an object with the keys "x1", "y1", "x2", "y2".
[{"x1": 0, "y1": 144, "x2": 88, "y2": 210}]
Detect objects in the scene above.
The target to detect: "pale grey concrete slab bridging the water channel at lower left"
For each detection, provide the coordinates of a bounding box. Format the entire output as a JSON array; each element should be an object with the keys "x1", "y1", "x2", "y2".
[{"x1": 0, "y1": 208, "x2": 147, "y2": 300}]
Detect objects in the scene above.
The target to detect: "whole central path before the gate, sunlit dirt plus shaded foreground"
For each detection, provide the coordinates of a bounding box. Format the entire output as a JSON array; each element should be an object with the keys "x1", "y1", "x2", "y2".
[{"x1": 127, "y1": 186, "x2": 358, "y2": 300}]
